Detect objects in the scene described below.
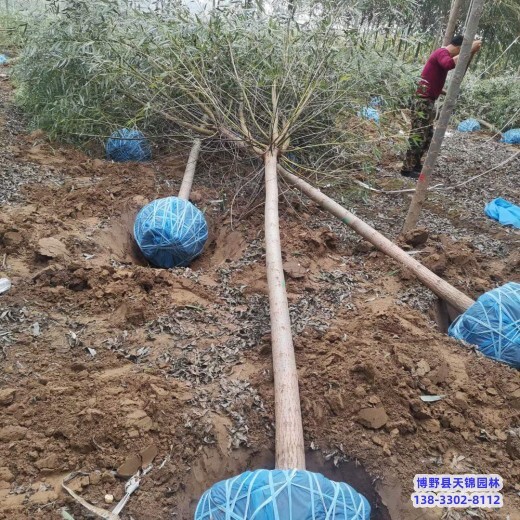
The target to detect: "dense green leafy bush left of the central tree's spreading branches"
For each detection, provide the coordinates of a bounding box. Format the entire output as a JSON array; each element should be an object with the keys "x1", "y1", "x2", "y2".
[{"x1": 13, "y1": 1, "x2": 152, "y2": 142}]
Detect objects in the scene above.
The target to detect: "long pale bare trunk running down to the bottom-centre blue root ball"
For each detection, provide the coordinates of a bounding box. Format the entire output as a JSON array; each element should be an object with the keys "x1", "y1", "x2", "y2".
[{"x1": 264, "y1": 150, "x2": 305, "y2": 469}]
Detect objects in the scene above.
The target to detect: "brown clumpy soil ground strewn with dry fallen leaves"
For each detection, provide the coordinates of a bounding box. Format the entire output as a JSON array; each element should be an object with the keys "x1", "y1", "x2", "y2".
[{"x1": 0, "y1": 72, "x2": 520, "y2": 520}]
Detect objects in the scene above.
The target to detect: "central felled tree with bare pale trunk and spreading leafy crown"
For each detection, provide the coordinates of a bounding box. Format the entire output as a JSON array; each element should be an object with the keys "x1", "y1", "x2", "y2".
[{"x1": 105, "y1": 3, "x2": 396, "y2": 469}]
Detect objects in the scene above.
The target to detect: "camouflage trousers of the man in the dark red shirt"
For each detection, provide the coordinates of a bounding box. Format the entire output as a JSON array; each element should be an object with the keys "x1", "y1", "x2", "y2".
[{"x1": 403, "y1": 97, "x2": 435, "y2": 171}]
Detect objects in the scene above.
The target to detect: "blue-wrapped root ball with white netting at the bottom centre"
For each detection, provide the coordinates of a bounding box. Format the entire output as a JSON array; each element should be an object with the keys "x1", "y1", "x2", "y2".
[{"x1": 195, "y1": 469, "x2": 370, "y2": 520}]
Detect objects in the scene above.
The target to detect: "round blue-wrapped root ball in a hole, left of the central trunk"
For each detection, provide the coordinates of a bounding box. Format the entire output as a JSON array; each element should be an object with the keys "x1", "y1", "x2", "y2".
[{"x1": 134, "y1": 197, "x2": 208, "y2": 269}]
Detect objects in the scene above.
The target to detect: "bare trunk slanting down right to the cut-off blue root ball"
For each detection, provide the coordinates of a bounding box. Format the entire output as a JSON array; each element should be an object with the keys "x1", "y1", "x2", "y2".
[{"x1": 278, "y1": 166, "x2": 476, "y2": 312}]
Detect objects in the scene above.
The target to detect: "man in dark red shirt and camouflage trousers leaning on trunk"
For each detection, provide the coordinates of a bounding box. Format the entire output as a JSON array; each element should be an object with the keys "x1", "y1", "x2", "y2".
[{"x1": 401, "y1": 35, "x2": 481, "y2": 179}]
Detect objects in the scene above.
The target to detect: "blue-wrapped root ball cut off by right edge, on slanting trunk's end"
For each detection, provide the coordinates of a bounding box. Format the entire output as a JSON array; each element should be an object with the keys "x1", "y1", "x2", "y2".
[{"x1": 448, "y1": 282, "x2": 520, "y2": 368}]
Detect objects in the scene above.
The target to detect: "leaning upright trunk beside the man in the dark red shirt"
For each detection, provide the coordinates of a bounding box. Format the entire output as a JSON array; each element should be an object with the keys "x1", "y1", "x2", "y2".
[{"x1": 403, "y1": 0, "x2": 484, "y2": 232}]
